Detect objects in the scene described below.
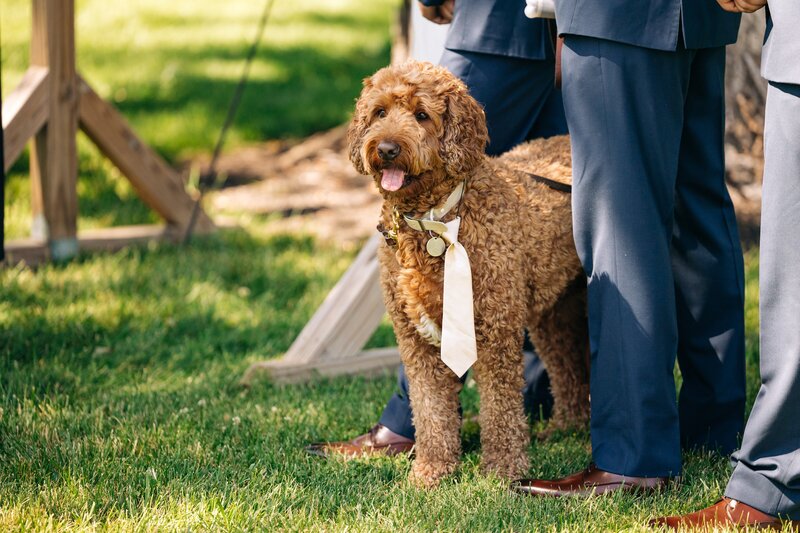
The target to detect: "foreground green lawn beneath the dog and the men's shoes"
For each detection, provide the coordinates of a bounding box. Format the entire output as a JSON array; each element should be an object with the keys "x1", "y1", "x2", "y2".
[{"x1": 0, "y1": 220, "x2": 757, "y2": 531}]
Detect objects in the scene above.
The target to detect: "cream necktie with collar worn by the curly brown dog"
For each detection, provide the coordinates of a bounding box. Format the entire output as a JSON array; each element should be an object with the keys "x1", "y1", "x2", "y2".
[{"x1": 404, "y1": 182, "x2": 478, "y2": 377}]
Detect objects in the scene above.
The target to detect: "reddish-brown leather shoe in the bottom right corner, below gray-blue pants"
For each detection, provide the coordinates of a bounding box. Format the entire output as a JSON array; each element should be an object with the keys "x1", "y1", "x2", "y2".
[{"x1": 649, "y1": 498, "x2": 800, "y2": 529}]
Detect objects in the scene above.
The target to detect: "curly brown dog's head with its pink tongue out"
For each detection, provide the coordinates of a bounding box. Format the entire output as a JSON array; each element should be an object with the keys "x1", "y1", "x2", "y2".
[{"x1": 347, "y1": 61, "x2": 488, "y2": 198}]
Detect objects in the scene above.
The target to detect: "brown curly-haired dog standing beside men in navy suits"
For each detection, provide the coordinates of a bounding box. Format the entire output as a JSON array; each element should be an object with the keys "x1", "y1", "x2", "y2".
[{"x1": 348, "y1": 61, "x2": 589, "y2": 487}]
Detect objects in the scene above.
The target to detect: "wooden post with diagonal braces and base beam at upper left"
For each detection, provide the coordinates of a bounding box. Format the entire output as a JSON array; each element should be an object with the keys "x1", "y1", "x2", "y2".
[{"x1": 2, "y1": 0, "x2": 214, "y2": 263}]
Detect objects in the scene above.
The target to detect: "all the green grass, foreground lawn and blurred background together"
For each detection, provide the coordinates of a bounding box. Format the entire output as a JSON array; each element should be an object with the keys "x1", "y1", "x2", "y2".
[{"x1": 0, "y1": 0, "x2": 772, "y2": 531}]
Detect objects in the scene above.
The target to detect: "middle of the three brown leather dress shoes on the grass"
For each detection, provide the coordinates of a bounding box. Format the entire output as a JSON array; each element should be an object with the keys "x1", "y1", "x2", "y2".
[{"x1": 511, "y1": 464, "x2": 674, "y2": 496}]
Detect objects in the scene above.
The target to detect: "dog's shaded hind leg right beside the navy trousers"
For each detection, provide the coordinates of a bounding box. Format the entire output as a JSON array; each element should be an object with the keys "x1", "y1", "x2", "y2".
[{"x1": 530, "y1": 279, "x2": 589, "y2": 429}]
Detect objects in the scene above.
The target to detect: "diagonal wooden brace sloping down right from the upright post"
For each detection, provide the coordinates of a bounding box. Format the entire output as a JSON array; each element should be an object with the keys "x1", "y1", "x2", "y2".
[{"x1": 78, "y1": 78, "x2": 214, "y2": 233}]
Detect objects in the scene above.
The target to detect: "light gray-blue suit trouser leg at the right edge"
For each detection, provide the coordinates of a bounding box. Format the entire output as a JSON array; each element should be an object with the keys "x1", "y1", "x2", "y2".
[{"x1": 725, "y1": 83, "x2": 800, "y2": 520}]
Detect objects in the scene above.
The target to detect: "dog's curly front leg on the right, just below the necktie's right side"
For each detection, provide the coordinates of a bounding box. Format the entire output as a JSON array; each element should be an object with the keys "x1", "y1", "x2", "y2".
[{"x1": 474, "y1": 312, "x2": 530, "y2": 478}]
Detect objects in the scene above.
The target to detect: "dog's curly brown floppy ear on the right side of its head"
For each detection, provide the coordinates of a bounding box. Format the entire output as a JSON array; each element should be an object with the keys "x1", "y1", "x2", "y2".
[{"x1": 440, "y1": 83, "x2": 489, "y2": 176}]
